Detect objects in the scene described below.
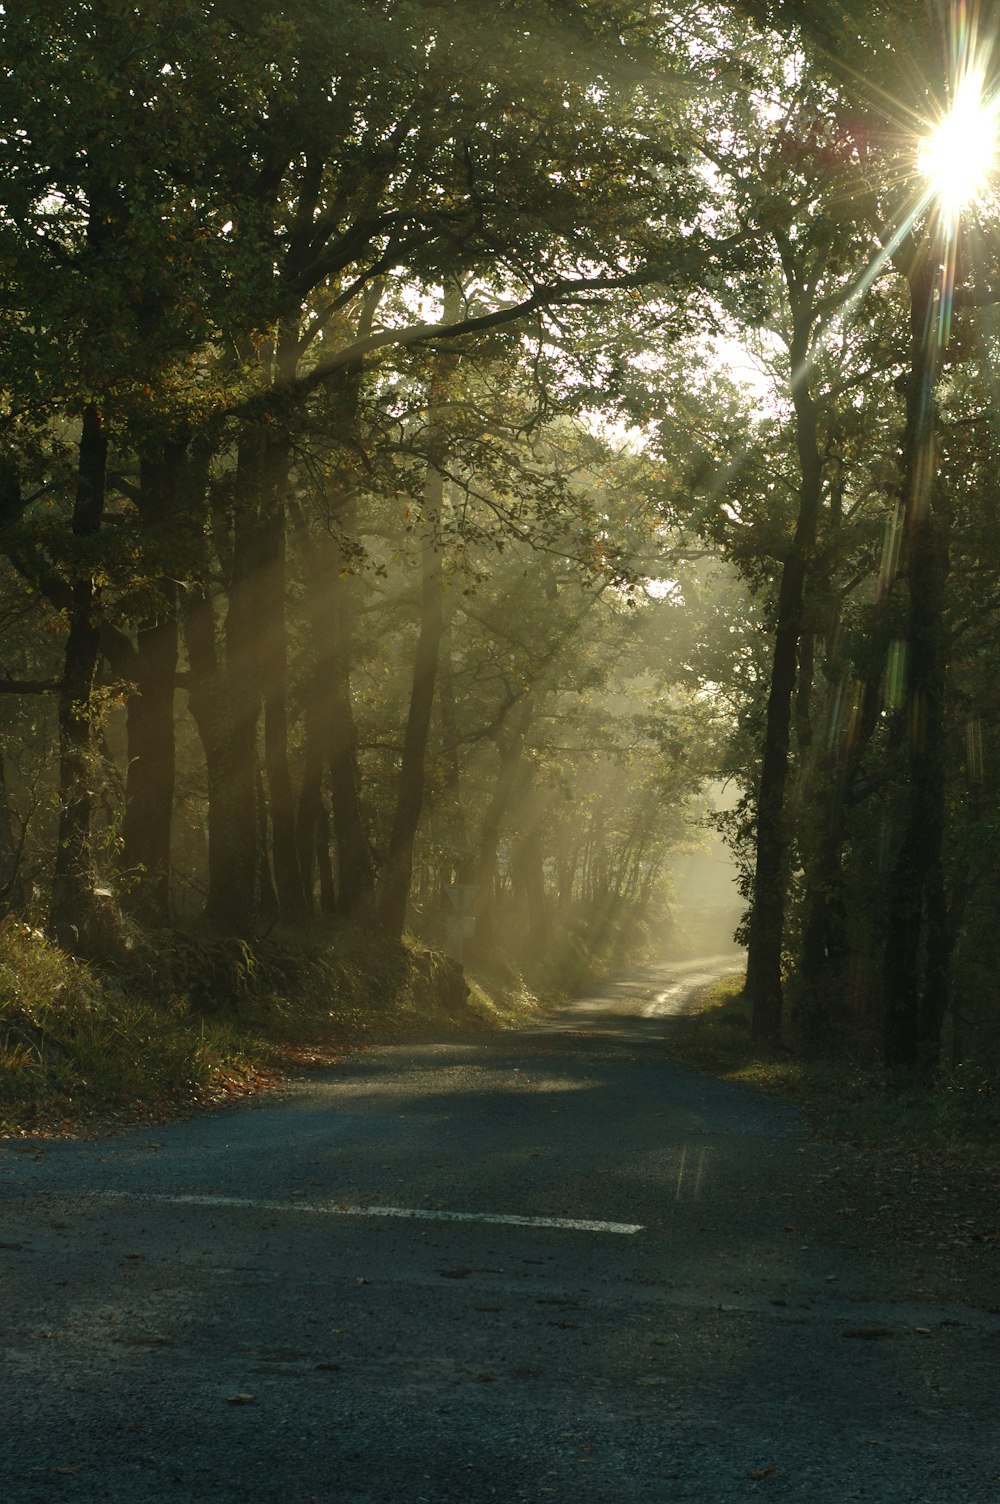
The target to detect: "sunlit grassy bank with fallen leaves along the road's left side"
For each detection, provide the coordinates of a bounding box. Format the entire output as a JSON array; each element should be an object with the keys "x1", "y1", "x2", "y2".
[{"x1": 0, "y1": 919, "x2": 532, "y2": 1137}]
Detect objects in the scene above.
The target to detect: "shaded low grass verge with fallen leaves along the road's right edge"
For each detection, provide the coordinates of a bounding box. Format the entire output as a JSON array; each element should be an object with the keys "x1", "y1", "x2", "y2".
[{"x1": 655, "y1": 976, "x2": 1000, "y2": 1164}]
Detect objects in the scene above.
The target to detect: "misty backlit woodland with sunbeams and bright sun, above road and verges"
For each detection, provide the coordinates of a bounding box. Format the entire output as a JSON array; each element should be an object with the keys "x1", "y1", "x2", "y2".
[{"x1": 0, "y1": 0, "x2": 1000, "y2": 1080}]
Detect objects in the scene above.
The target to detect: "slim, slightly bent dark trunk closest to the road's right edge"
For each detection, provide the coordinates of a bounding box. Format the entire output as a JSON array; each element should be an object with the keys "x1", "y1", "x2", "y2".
[{"x1": 747, "y1": 279, "x2": 823, "y2": 1045}]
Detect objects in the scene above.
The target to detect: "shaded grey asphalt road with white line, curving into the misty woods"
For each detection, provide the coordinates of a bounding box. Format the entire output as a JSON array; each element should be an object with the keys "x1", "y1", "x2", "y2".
[{"x1": 0, "y1": 957, "x2": 1000, "y2": 1504}]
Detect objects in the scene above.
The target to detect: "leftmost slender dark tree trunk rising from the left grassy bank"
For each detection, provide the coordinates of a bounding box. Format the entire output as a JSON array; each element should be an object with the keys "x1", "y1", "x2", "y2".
[{"x1": 51, "y1": 403, "x2": 108, "y2": 948}]
